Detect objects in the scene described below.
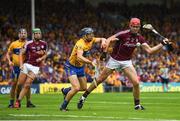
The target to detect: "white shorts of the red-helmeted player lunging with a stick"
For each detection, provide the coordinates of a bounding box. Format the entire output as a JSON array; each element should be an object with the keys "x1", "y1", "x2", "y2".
[{"x1": 106, "y1": 57, "x2": 133, "y2": 70}]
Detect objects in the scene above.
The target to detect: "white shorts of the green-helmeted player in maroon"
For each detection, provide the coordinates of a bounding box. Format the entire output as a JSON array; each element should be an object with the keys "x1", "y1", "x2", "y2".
[{"x1": 21, "y1": 63, "x2": 39, "y2": 75}]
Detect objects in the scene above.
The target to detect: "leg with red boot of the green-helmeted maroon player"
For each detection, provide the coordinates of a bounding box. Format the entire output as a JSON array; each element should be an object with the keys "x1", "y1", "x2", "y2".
[{"x1": 15, "y1": 71, "x2": 36, "y2": 108}]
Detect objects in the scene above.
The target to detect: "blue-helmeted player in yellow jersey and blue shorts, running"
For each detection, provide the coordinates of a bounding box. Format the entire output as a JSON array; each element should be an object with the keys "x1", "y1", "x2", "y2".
[{"x1": 60, "y1": 27, "x2": 106, "y2": 111}]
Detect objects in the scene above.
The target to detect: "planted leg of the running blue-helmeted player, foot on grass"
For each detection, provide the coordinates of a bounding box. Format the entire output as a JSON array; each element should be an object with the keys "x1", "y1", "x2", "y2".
[{"x1": 60, "y1": 75, "x2": 80, "y2": 111}]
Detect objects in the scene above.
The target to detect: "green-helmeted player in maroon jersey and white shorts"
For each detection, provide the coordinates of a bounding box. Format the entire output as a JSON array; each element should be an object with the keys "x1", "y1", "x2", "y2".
[{"x1": 14, "y1": 28, "x2": 47, "y2": 108}]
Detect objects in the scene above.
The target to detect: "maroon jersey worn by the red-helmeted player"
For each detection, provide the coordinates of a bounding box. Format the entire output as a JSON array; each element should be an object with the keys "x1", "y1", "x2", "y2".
[{"x1": 111, "y1": 30, "x2": 146, "y2": 61}]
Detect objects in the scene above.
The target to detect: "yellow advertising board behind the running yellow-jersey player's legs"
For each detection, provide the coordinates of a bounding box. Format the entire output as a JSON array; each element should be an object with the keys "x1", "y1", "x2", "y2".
[{"x1": 40, "y1": 83, "x2": 104, "y2": 94}]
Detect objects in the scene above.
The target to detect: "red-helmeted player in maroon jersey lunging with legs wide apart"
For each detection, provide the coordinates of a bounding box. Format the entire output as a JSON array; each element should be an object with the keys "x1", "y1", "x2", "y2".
[{"x1": 77, "y1": 18, "x2": 168, "y2": 110}]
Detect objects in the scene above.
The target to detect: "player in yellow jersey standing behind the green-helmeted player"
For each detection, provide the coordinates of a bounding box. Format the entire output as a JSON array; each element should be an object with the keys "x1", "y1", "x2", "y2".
[{"x1": 6, "y1": 28, "x2": 35, "y2": 108}]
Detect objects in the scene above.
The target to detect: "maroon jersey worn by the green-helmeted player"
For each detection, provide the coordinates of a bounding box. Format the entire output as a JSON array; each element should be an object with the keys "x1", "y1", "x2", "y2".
[{"x1": 24, "y1": 40, "x2": 47, "y2": 67}]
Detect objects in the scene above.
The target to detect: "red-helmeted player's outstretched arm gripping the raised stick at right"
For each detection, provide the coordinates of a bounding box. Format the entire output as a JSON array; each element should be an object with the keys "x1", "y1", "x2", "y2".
[{"x1": 142, "y1": 39, "x2": 168, "y2": 54}]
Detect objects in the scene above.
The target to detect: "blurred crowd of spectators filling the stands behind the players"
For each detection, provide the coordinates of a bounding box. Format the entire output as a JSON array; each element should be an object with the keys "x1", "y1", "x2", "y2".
[{"x1": 0, "y1": 0, "x2": 180, "y2": 86}]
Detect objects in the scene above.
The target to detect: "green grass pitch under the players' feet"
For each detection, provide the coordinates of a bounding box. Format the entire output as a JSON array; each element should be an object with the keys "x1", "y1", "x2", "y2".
[{"x1": 0, "y1": 93, "x2": 180, "y2": 120}]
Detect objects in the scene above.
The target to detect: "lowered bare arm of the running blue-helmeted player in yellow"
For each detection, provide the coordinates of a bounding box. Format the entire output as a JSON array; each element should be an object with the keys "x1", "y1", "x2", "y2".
[{"x1": 77, "y1": 49, "x2": 95, "y2": 66}]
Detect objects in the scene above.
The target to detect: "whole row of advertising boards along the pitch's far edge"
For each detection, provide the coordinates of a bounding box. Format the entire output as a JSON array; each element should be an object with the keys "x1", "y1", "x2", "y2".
[{"x1": 0, "y1": 82, "x2": 180, "y2": 94}]
